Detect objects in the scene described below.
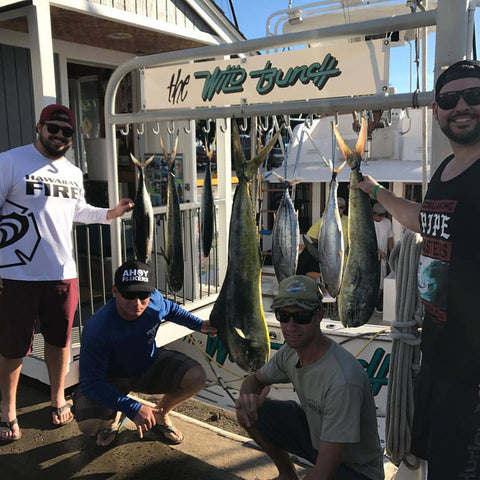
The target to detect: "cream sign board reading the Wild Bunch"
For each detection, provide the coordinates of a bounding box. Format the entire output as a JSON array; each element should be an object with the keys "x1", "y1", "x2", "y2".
[{"x1": 143, "y1": 40, "x2": 389, "y2": 110}]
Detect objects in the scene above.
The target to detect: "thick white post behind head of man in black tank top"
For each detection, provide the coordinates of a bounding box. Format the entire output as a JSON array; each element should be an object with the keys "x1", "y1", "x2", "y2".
[{"x1": 431, "y1": 0, "x2": 470, "y2": 173}]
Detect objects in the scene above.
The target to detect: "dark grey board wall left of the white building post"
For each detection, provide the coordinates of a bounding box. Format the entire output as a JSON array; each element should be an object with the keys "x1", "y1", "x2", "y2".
[{"x1": 0, "y1": 44, "x2": 35, "y2": 152}]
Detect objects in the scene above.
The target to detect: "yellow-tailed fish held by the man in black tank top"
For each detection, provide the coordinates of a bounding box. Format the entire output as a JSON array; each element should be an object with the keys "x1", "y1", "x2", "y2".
[{"x1": 335, "y1": 119, "x2": 380, "y2": 327}]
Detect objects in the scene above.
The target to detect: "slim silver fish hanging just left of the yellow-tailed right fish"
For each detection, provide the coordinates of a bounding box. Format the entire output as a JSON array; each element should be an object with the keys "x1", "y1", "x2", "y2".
[{"x1": 318, "y1": 152, "x2": 345, "y2": 297}]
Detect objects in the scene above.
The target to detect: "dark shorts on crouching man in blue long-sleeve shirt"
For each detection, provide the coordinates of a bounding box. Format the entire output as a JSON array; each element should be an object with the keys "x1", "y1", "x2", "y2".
[{"x1": 73, "y1": 348, "x2": 200, "y2": 422}]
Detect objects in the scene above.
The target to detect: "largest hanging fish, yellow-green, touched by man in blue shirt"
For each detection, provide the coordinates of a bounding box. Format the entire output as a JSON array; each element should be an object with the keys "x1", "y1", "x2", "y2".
[{"x1": 210, "y1": 121, "x2": 280, "y2": 371}]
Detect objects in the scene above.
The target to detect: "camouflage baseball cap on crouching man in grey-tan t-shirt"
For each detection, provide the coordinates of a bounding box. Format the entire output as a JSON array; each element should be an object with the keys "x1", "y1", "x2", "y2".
[{"x1": 272, "y1": 275, "x2": 322, "y2": 310}]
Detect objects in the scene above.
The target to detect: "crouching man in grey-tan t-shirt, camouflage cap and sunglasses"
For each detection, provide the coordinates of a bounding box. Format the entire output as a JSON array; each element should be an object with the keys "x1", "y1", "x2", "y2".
[{"x1": 235, "y1": 275, "x2": 384, "y2": 480}]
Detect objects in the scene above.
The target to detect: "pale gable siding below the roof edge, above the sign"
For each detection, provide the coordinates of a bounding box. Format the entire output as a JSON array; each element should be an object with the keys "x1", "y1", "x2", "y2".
[{"x1": 88, "y1": 0, "x2": 214, "y2": 34}]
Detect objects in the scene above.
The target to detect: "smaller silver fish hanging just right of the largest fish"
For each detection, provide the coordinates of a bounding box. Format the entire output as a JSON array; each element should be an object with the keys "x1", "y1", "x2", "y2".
[{"x1": 272, "y1": 173, "x2": 300, "y2": 282}]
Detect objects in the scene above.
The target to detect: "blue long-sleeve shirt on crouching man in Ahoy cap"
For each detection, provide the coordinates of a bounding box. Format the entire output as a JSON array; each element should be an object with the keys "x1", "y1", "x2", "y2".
[{"x1": 80, "y1": 290, "x2": 202, "y2": 420}]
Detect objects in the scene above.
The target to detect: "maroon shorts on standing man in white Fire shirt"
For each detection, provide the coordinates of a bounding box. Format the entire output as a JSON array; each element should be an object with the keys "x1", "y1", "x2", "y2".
[{"x1": 0, "y1": 278, "x2": 78, "y2": 358}]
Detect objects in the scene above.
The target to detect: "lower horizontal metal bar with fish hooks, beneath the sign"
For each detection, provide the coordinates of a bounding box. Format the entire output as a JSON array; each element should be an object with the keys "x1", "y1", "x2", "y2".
[{"x1": 109, "y1": 91, "x2": 434, "y2": 124}]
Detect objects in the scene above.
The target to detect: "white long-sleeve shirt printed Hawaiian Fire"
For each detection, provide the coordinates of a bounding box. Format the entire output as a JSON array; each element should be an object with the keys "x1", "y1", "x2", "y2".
[{"x1": 0, "y1": 145, "x2": 109, "y2": 281}]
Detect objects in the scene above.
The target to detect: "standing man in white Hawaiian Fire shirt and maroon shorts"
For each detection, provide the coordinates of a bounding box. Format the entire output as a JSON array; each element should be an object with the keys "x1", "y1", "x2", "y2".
[{"x1": 0, "y1": 105, "x2": 133, "y2": 442}]
